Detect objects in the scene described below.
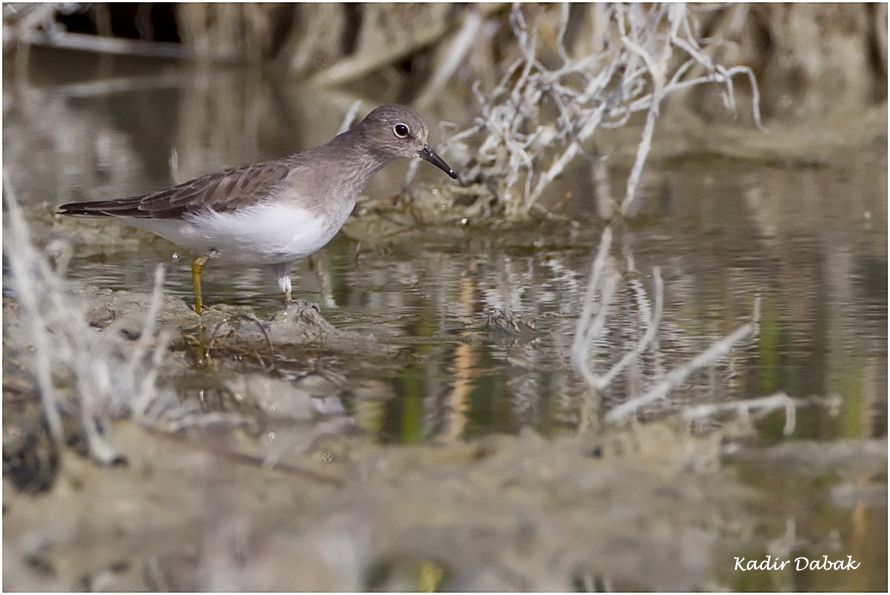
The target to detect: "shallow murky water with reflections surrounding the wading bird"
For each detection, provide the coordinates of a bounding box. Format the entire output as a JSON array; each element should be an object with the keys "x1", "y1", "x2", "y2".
[{"x1": 3, "y1": 47, "x2": 887, "y2": 590}]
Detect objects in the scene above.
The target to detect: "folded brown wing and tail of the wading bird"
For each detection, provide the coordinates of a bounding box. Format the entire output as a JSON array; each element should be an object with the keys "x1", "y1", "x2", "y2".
[{"x1": 57, "y1": 161, "x2": 289, "y2": 219}]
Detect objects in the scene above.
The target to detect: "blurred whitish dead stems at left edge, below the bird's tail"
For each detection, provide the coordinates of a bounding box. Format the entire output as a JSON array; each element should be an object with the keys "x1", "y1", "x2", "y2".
[{"x1": 3, "y1": 179, "x2": 237, "y2": 464}]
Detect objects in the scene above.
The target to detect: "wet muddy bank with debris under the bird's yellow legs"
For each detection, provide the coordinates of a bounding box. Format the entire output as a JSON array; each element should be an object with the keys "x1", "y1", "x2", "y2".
[{"x1": 3, "y1": 287, "x2": 372, "y2": 472}]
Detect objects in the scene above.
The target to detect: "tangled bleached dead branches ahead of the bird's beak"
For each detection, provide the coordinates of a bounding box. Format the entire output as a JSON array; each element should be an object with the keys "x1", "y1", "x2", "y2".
[{"x1": 439, "y1": 4, "x2": 760, "y2": 216}]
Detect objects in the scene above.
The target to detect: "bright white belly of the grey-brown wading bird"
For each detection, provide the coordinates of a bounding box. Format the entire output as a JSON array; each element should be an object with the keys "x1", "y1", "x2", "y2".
[{"x1": 130, "y1": 201, "x2": 354, "y2": 264}]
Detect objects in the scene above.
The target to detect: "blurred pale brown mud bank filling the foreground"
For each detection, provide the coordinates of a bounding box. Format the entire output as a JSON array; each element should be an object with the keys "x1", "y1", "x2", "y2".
[{"x1": 4, "y1": 423, "x2": 751, "y2": 590}]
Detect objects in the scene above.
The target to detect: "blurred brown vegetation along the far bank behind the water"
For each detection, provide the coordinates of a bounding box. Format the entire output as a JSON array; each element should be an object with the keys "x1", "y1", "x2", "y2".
[{"x1": 3, "y1": 3, "x2": 887, "y2": 121}]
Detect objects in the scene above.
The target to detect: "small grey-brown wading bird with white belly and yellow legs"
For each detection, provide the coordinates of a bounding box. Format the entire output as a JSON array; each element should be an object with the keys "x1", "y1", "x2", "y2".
[{"x1": 57, "y1": 105, "x2": 457, "y2": 314}]
